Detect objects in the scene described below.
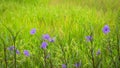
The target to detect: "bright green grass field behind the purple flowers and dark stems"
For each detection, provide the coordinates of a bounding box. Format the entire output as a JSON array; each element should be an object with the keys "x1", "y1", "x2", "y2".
[{"x1": 0, "y1": 0, "x2": 120, "y2": 68}]
